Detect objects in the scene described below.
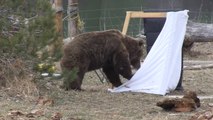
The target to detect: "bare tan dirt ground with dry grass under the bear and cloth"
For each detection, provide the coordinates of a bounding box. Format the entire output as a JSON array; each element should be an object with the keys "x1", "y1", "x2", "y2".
[{"x1": 0, "y1": 43, "x2": 213, "y2": 120}]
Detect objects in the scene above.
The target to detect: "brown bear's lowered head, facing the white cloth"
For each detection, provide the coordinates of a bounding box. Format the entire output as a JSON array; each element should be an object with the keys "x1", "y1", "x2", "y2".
[{"x1": 123, "y1": 35, "x2": 144, "y2": 69}]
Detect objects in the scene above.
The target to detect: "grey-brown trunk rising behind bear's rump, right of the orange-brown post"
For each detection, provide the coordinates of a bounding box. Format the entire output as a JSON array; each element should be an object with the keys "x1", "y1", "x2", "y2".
[{"x1": 67, "y1": 0, "x2": 80, "y2": 38}]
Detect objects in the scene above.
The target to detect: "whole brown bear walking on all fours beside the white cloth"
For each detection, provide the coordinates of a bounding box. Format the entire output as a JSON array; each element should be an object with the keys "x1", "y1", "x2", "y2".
[{"x1": 61, "y1": 30, "x2": 144, "y2": 90}]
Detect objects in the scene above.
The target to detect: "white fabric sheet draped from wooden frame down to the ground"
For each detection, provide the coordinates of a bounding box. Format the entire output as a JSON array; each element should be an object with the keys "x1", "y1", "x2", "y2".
[{"x1": 109, "y1": 10, "x2": 188, "y2": 95}]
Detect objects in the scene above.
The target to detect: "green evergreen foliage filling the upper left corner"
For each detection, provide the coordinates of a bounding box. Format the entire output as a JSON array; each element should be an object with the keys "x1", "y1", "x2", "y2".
[{"x1": 0, "y1": 0, "x2": 60, "y2": 56}]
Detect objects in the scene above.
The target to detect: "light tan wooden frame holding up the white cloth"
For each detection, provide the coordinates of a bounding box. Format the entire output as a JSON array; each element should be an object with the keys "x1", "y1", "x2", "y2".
[{"x1": 122, "y1": 11, "x2": 166, "y2": 35}]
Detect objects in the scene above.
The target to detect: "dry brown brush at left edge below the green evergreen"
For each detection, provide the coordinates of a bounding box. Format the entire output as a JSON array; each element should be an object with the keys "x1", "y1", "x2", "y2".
[{"x1": 0, "y1": 55, "x2": 38, "y2": 98}]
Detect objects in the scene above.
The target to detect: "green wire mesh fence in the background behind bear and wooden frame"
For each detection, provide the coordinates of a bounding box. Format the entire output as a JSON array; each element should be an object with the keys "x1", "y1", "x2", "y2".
[{"x1": 64, "y1": 0, "x2": 213, "y2": 37}]
